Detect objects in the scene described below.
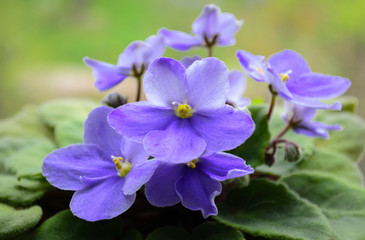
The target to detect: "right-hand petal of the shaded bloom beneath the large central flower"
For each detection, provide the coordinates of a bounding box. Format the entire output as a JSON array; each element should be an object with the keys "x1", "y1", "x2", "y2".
[{"x1": 197, "y1": 152, "x2": 254, "y2": 181}]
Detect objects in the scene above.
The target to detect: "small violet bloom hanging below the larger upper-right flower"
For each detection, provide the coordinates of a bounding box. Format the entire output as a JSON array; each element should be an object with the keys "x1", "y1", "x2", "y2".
[{"x1": 283, "y1": 101, "x2": 342, "y2": 138}]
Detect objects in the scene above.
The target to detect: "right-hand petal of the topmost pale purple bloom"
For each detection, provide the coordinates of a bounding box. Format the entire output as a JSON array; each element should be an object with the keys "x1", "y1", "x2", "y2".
[{"x1": 218, "y1": 13, "x2": 243, "y2": 46}]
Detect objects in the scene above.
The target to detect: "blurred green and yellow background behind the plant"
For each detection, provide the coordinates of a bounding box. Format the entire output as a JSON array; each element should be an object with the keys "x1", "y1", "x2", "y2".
[{"x1": 0, "y1": 0, "x2": 365, "y2": 172}]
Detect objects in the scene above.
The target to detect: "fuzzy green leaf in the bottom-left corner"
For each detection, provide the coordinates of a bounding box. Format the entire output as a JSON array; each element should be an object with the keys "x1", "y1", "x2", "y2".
[{"x1": 0, "y1": 203, "x2": 42, "y2": 239}]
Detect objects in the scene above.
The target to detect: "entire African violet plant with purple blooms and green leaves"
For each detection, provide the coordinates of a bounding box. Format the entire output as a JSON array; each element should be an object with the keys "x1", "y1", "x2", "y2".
[{"x1": 0, "y1": 5, "x2": 365, "y2": 240}]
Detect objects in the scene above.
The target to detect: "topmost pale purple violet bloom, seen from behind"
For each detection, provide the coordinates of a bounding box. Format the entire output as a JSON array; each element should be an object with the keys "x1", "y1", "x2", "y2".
[{"x1": 159, "y1": 4, "x2": 243, "y2": 51}]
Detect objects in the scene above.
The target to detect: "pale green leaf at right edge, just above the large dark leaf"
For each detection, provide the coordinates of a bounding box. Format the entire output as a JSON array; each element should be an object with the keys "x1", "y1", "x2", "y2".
[{"x1": 300, "y1": 148, "x2": 363, "y2": 186}]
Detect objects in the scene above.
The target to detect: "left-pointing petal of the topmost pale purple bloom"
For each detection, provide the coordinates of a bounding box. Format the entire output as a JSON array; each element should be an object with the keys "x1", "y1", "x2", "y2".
[{"x1": 158, "y1": 28, "x2": 203, "y2": 51}]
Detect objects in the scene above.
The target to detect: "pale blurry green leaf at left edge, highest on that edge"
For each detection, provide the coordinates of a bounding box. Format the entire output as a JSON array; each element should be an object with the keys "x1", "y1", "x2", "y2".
[{"x1": 0, "y1": 105, "x2": 51, "y2": 138}]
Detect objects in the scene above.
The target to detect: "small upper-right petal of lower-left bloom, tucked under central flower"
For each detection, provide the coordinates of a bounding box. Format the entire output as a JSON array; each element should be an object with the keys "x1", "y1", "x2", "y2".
[{"x1": 120, "y1": 138, "x2": 149, "y2": 165}]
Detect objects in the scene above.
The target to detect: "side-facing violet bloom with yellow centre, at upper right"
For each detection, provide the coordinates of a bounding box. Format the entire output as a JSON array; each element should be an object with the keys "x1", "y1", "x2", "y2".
[{"x1": 237, "y1": 50, "x2": 351, "y2": 110}]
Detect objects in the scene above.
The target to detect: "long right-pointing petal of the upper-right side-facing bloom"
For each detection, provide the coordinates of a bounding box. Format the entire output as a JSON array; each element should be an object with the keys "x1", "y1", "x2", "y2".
[{"x1": 286, "y1": 73, "x2": 351, "y2": 99}]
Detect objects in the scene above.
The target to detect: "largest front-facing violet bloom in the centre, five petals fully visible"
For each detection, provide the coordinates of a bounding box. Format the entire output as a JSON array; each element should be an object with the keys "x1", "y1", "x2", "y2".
[{"x1": 108, "y1": 58, "x2": 254, "y2": 163}]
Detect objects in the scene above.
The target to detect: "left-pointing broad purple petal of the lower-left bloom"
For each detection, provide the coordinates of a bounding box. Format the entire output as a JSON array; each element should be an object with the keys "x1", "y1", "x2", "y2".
[{"x1": 42, "y1": 144, "x2": 114, "y2": 191}]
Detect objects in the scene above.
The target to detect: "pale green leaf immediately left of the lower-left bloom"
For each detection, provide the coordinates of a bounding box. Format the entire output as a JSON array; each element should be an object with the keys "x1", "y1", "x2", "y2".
[{"x1": 5, "y1": 140, "x2": 56, "y2": 178}]
